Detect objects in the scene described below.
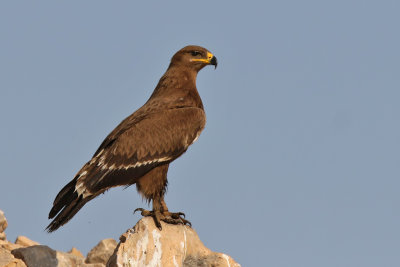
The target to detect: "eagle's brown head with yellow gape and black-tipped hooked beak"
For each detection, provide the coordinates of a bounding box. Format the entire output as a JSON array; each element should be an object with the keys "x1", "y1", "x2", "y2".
[{"x1": 170, "y1": 45, "x2": 218, "y2": 71}]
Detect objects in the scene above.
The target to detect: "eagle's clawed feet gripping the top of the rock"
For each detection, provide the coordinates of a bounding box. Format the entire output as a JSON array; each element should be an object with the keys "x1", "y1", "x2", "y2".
[{"x1": 133, "y1": 208, "x2": 192, "y2": 230}]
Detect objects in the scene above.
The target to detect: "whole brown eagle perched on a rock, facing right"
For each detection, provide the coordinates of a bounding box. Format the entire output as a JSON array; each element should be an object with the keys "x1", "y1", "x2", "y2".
[{"x1": 46, "y1": 45, "x2": 218, "y2": 232}]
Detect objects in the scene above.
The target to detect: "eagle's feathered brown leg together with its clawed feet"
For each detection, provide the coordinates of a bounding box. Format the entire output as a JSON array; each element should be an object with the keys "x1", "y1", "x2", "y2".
[{"x1": 135, "y1": 164, "x2": 191, "y2": 230}]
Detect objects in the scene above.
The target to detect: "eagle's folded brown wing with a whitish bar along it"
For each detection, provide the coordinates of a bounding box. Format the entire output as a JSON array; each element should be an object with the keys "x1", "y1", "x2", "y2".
[{"x1": 76, "y1": 107, "x2": 205, "y2": 196}]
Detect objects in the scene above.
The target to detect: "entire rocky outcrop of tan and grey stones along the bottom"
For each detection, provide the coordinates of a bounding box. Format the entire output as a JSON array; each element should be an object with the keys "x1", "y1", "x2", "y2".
[{"x1": 0, "y1": 210, "x2": 240, "y2": 267}]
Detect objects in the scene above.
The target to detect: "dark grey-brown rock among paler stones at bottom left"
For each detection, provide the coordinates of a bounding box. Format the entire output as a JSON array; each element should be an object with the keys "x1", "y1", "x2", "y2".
[{"x1": 11, "y1": 245, "x2": 58, "y2": 267}]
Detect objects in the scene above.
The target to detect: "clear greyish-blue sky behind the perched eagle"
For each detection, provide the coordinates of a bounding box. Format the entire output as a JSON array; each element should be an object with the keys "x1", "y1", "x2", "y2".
[{"x1": 0, "y1": 0, "x2": 400, "y2": 267}]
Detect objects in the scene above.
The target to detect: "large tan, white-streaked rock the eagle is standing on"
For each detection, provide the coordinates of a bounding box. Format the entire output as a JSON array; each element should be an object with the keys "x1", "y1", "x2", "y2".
[{"x1": 107, "y1": 217, "x2": 240, "y2": 267}]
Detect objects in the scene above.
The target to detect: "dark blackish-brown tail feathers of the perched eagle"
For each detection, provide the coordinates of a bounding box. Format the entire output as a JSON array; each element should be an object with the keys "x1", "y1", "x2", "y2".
[{"x1": 46, "y1": 178, "x2": 93, "y2": 233}]
